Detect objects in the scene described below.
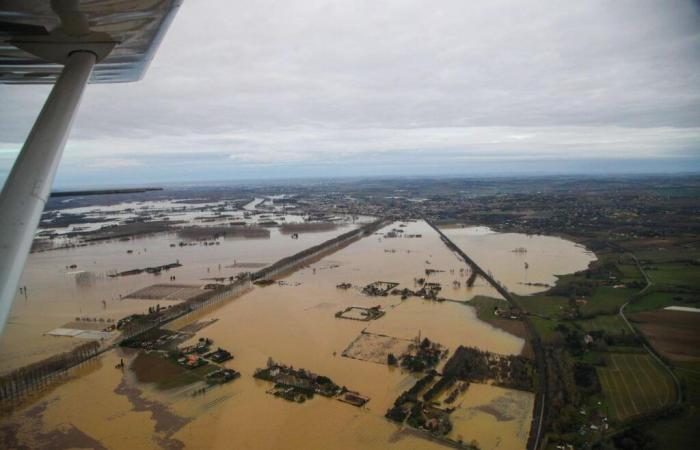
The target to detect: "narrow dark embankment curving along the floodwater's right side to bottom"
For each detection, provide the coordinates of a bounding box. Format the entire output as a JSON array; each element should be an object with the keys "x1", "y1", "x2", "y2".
[{"x1": 425, "y1": 219, "x2": 549, "y2": 450}]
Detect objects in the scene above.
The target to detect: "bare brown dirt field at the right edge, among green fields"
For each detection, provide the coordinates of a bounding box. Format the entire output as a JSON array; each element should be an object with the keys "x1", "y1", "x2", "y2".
[{"x1": 630, "y1": 310, "x2": 700, "y2": 361}]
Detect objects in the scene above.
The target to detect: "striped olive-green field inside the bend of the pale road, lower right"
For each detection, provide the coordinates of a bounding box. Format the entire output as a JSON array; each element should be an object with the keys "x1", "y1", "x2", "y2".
[{"x1": 597, "y1": 353, "x2": 676, "y2": 421}]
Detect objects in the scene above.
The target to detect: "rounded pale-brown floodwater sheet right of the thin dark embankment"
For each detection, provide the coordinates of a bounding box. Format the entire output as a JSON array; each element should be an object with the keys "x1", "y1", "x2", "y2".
[{"x1": 441, "y1": 227, "x2": 596, "y2": 295}]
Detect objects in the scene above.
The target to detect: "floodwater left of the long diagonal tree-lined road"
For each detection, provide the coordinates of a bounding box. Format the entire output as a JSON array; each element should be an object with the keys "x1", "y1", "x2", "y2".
[{"x1": 0, "y1": 224, "x2": 355, "y2": 373}]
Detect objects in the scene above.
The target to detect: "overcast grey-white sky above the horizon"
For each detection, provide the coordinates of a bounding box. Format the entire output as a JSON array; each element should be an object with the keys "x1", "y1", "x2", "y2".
[{"x1": 0, "y1": 0, "x2": 700, "y2": 187}]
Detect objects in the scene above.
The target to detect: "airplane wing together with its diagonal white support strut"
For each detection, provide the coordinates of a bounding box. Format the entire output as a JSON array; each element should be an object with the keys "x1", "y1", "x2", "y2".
[{"x1": 0, "y1": 0, "x2": 181, "y2": 334}]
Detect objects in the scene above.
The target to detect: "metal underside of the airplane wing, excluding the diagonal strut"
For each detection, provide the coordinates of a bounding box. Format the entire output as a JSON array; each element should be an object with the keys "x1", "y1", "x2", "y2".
[{"x1": 0, "y1": 0, "x2": 182, "y2": 84}]
